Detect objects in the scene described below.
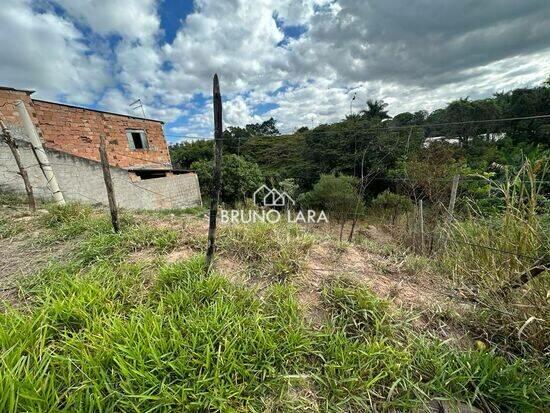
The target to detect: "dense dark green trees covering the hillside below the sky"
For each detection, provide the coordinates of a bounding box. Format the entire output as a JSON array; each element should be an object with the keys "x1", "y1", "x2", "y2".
[{"x1": 171, "y1": 81, "x2": 550, "y2": 202}]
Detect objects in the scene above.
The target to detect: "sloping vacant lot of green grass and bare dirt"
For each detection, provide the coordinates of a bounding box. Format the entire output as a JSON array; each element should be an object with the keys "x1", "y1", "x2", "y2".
[{"x1": 0, "y1": 200, "x2": 550, "y2": 412}]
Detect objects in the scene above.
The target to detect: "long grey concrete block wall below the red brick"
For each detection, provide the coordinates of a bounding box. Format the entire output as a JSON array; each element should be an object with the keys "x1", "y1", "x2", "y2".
[{"x1": 0, "y1": 140, "x2": 201, "y2": 209}]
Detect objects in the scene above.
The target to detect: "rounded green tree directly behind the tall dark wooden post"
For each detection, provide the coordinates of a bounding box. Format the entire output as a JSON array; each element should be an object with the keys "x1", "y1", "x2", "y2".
[{"x1": 191, "y1": 154, "x2": 264, "y2": 204}]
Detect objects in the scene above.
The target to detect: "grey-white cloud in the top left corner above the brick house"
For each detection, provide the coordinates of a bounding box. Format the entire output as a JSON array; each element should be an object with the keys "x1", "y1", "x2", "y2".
[{"x1": 0, "y1": 0, "x2": 110, "y2": 103}]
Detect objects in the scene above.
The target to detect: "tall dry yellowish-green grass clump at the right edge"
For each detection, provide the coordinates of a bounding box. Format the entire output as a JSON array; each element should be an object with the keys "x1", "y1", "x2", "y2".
[{"x1": 444, "y1": 162, "x2": 550, "y2": 354}]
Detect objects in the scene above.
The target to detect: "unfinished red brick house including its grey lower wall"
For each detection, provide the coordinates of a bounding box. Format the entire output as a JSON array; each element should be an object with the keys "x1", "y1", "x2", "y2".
[{"x1": 0, "y1": 86, "x2": 201, "y2": 208}]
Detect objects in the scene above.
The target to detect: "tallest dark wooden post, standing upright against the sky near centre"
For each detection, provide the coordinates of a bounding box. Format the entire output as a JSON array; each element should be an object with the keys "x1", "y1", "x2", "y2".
[{"x1": 206, "y1": 74, "x2": 222, "y2": 272}]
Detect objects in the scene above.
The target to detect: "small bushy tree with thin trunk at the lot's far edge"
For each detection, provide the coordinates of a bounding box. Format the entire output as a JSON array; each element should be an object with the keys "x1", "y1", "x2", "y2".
[{"x1": 298, "y1": 175, "x2": 364, "y2": 241}]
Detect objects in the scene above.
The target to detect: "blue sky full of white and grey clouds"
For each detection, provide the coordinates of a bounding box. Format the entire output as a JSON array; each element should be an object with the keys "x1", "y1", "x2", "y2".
[{"x1": 0, "y1": 0, "x2": 550, "y2": 143}]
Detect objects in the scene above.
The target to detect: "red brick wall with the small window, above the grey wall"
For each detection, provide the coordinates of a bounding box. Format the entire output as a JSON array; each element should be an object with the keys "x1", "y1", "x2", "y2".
[{"x1": 33, "y1": 100, "x2": 170, "y2": 168}]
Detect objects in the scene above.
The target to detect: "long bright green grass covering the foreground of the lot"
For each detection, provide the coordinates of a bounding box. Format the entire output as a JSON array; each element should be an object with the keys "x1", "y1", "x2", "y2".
[{"x1": 0, "y1": 200, "x2": 550, "y2": 412}]
